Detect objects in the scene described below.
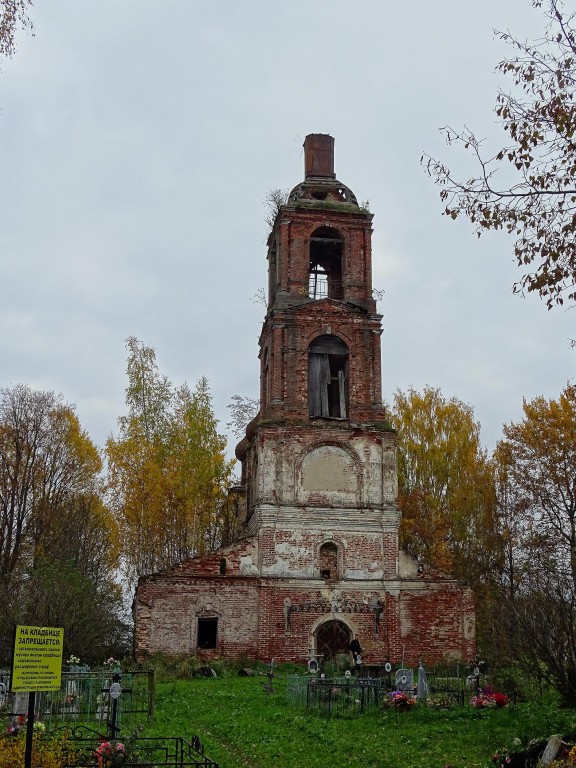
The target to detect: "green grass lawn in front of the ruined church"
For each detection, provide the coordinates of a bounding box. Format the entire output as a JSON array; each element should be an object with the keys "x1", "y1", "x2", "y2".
[{"x1": 137, "y1": 676, "x2": 576, "y2": 768}]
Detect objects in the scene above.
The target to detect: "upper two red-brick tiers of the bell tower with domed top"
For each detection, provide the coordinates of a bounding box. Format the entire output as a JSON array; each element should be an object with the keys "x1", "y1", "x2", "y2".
[{"x1": 260, "y1": 134, "x2": 385, "y2": 426}]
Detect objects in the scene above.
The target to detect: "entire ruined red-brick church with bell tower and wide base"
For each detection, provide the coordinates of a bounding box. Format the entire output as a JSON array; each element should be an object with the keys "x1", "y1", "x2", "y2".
[{"x1": 134, "y1": 134, "x2": 475, "y2": 664}]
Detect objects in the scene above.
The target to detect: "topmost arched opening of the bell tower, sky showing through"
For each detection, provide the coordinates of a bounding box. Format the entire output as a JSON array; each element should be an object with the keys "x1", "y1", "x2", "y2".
[{"x1": 308, "y1": 227, "x2": 344, "y2": 299}]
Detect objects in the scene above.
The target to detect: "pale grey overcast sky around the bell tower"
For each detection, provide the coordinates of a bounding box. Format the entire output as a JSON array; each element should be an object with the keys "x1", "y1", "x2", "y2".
[{"x1": 0, "y1": 0, "x2": 576, "y2": 456}]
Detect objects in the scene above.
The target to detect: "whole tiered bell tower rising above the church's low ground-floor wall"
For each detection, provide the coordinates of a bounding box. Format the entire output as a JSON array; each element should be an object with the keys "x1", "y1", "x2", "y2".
[{"x1": 236, "y1": 134, "x2": 399, "y2": 588}]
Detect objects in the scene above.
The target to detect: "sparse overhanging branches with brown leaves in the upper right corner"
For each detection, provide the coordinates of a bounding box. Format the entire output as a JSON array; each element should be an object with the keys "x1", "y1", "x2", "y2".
[{"x1": 422, "y1": 0, "x2": 576, "y2": 309}]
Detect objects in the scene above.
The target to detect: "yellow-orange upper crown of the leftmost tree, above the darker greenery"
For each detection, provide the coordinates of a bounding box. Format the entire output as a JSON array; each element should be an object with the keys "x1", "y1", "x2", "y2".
[{"x1": 0, "y1": 384, "x2": 113, "y2": 587}]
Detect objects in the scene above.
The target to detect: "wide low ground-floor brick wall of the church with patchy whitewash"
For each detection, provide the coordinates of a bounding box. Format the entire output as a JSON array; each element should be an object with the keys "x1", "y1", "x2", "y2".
[{"x1": 136, "y1": 560, "x2": 475, "y2": 665}]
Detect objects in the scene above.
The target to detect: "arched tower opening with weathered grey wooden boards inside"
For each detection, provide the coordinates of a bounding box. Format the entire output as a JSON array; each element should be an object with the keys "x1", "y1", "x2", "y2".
[{"x1": 308, "y1": 335, "x2": 348, "y2": 419}]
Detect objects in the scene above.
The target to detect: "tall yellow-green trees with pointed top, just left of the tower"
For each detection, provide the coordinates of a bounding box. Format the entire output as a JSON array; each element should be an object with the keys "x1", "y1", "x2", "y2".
[{"x1": 106, "y1": 338, "x2": 233, "y2": 578}]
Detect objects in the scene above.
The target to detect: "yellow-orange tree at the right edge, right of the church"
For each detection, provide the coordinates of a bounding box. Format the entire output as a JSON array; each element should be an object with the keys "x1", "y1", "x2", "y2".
[{"x1": 496, "y1": 385, "x2": 576, "y2": 706}]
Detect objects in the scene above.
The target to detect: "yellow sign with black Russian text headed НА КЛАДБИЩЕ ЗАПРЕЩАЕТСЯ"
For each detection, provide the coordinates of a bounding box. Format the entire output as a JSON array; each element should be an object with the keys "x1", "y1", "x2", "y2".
[{"x1": 11, "y1": 626, "x2": 64, "y2": 691}]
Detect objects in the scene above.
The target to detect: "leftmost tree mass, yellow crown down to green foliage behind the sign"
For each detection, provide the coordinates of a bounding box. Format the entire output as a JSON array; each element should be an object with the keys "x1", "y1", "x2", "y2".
[{"x1": 0, "y1": 384, "x2": 125, "y2": 664}]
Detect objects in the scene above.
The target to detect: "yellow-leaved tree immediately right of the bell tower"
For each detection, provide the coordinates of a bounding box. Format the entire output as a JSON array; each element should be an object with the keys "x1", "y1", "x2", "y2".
[{"x1": 391, "y1": 387, "x2": 495, "y2": 581}]
